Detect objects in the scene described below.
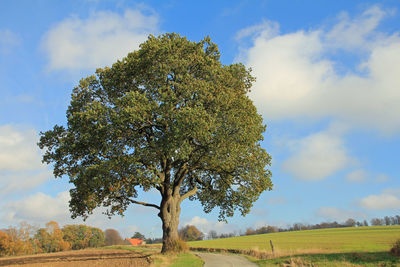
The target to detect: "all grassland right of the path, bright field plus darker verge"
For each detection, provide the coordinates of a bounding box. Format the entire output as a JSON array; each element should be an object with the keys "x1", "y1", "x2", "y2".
[{"x1": 188, "y1": 226, "x2": 400, "y2": 267}]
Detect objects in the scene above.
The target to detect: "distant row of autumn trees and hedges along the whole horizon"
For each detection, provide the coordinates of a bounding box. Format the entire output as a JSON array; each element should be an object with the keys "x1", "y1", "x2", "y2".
[{"x1": 0, "y1": 215, "x2": 394, "y2": 256}]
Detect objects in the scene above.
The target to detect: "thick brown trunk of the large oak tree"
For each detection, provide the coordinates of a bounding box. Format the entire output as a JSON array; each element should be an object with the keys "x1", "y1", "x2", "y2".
[{"x1": 158, "y1": 194, "x2": 182, "y2": 254}]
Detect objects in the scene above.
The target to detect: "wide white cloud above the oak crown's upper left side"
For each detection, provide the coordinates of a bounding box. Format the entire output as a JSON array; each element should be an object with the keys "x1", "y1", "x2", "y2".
[{"x1": 43, "y1": 9, "x2": 158, "y2": 70}]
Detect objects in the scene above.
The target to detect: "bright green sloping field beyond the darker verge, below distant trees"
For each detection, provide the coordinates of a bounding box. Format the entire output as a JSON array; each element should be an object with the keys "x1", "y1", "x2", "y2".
[{"x1": 188, "y1": 226, "x2": 400, "y2": 253}]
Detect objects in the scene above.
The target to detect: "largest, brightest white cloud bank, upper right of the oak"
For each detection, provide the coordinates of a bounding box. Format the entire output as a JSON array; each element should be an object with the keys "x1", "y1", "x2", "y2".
[{"x1": 238, "y1": 6, "x2": 400, "y2": 134}]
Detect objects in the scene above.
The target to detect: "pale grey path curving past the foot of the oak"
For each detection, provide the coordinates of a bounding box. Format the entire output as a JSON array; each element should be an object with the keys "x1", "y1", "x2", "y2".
[{"x1": 194, "y1": 252, "x2": 257, "y2": 267}]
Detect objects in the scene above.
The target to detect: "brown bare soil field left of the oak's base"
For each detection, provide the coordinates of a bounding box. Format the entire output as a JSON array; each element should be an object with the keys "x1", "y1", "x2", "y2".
[{"x1": 0, "y1": 249, "x2": 151, "y2": 267}]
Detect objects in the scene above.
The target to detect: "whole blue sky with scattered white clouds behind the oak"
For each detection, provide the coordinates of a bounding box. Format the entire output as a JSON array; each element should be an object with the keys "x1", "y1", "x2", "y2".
[{"x1": 0, "y1": 0, "x2": 400, "y2": 237}]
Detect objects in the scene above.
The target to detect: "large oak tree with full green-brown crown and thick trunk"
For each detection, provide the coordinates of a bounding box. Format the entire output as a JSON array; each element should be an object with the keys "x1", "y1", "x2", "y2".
[{"x1": 39, "y1": 33, "x2": 272, "y2": 253}]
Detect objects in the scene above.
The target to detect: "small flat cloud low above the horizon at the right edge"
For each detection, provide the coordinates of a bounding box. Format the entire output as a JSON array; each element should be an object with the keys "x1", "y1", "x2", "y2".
[{"x1": 360, "y1": 192, "x2": 400, "y2": 210}]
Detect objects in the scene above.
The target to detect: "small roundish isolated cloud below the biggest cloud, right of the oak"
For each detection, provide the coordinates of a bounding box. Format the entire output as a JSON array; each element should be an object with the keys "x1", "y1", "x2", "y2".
[{"x1": 282, "y1": 128, "x2": 355, "y2": 181}]
